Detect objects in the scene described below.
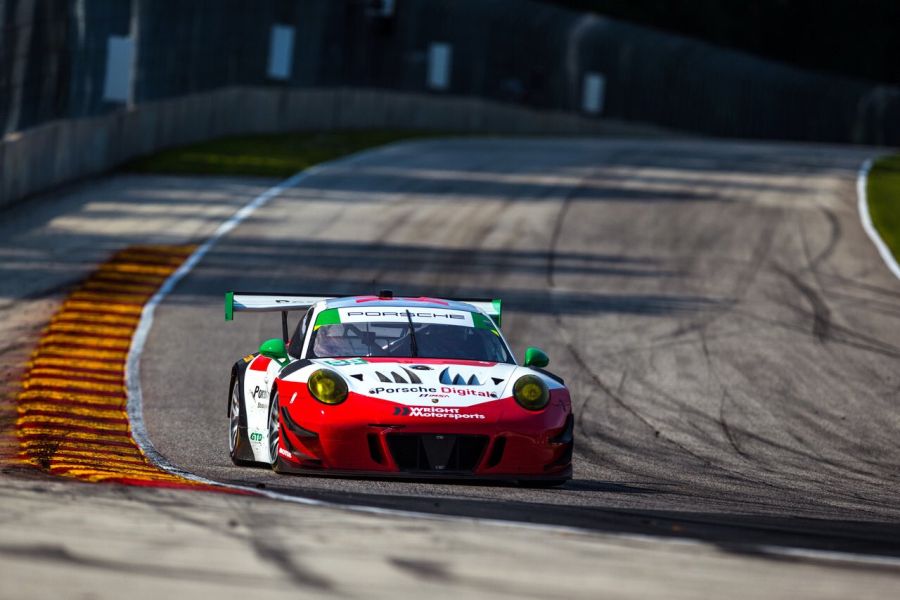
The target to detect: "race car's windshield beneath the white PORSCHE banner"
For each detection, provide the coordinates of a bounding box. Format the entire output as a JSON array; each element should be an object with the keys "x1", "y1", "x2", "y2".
[{"x1": 309, "y1": 310, "x2": 513, "y2": 363}]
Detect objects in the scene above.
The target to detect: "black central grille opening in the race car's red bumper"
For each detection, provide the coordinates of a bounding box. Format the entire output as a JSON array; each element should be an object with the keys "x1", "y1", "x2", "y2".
[{"x1": 387, "y1": 433, "x2": 488, "y2": 473}]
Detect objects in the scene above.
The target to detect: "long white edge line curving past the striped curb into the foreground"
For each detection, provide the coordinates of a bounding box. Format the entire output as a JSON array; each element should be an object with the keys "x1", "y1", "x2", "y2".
[{"x1": 119, "y1": 142, "x2": 900, "y2": 567}]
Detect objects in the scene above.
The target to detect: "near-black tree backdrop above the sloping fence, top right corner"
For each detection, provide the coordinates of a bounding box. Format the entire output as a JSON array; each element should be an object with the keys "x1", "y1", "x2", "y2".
[{"x1": 542, "y1": 0, "x2": 900, "y2": 83}]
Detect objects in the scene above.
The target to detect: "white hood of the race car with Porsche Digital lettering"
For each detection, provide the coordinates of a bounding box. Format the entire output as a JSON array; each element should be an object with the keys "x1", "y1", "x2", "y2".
[{"x1": 304, "y1": 358, "x2": 531, "y2": 407}]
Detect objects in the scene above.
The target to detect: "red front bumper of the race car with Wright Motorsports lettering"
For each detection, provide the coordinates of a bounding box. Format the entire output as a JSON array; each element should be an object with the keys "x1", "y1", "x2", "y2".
[{"x1": 276, "y1": 380, "x2": 573, "y2": 480}]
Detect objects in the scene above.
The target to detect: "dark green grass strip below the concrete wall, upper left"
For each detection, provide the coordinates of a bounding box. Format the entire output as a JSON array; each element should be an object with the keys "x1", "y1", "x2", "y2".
[{"x1": 123, "y1": 130, "x2": 450, "y2": 177}]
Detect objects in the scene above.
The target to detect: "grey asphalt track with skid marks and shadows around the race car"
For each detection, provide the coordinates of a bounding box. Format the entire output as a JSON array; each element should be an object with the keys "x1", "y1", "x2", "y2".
[{"x1": 141, "y1": 139, "x2": 900, "y2": 555}]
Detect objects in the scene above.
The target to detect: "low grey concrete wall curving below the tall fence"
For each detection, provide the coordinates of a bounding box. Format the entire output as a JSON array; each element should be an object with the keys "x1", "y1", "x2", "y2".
[{"x1": 0, "y1": 87, "x2": 656, "y2": 207}]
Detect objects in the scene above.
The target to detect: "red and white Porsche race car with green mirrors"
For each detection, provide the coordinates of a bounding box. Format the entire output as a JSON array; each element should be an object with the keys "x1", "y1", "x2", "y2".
[{"x1": 225, "y1": 291, "x2": 574, "y2": 486}]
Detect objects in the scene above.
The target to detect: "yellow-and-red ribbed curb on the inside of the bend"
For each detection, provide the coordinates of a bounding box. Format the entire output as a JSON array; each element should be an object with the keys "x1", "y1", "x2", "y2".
[{"x1": 15, "y1": 245, "x2": 227, "y2": 489}]
